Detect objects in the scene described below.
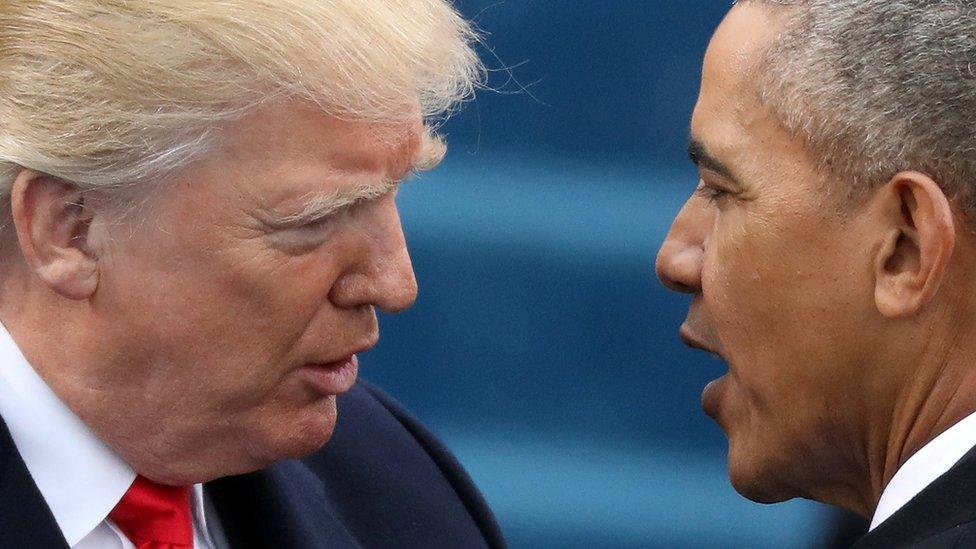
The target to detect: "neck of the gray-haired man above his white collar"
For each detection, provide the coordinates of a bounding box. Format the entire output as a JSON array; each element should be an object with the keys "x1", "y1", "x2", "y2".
[{"x1": 796, "y1": 302, "x2": 976, "y2": 518}]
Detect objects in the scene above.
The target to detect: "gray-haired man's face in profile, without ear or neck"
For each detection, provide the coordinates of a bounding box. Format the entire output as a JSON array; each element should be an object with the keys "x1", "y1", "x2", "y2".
[{"x1": 657, "y1": 4, "x2": 875, "y2": 501}]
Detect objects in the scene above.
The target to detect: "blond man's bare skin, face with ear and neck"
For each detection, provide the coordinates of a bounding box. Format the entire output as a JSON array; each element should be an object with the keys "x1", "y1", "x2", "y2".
[{"x1": 0, "y1": 99, "x2": 424, "y2": 484}]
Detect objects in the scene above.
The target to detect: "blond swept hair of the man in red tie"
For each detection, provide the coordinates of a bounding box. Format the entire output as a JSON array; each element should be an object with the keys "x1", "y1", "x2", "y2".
[{"x1": 0, "y1": 0, "x2": 483, "y2": 216}]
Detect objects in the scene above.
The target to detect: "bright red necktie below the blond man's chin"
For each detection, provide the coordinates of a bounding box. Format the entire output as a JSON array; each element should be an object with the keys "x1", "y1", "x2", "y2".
[{"x1": 108, "y1": 476, "x2": 193, "y2": 549}]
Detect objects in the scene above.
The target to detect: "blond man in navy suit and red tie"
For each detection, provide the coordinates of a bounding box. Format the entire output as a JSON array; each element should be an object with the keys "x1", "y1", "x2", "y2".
[{"x1": 0, "y1": 0, "x2": 504, "y2": 549}]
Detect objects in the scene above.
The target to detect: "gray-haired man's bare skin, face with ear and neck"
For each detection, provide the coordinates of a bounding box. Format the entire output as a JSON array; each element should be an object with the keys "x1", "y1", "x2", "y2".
[{"x1": 657, "y1": 3, "x2": 976, "y2": 516}]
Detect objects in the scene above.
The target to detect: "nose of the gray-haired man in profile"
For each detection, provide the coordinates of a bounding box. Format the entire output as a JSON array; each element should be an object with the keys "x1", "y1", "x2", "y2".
[{"x1": 655, "y1": 196, "x2": 714, "y2": 294}]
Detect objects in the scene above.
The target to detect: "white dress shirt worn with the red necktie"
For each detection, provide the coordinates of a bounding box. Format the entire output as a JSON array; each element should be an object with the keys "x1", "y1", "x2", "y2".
[{"x1": 0, "y1": 325, "x2": 227, "y2": 549}]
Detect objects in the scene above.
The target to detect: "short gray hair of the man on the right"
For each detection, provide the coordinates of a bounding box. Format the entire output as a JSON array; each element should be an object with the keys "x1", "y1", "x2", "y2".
[{"x1": 750, "y1": 0, "x2": 976, "y2": 212}]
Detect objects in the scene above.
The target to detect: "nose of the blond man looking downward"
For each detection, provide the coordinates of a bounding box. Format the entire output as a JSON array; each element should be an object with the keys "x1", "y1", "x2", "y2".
[{"x1": 329, "y1": 196, "x2": 417, "y2": 313}]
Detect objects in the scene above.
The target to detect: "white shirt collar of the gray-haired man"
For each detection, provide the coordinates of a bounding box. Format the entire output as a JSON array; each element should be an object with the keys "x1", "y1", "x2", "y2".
[{"x1": 870, "y1": 413, "x2": 976, "y2": 530}]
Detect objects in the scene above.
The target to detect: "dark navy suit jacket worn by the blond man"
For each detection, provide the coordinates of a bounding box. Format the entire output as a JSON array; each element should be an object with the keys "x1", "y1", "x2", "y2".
[{"x1": 0, "y1": 381, "x2": 505, "y2": 549}]
